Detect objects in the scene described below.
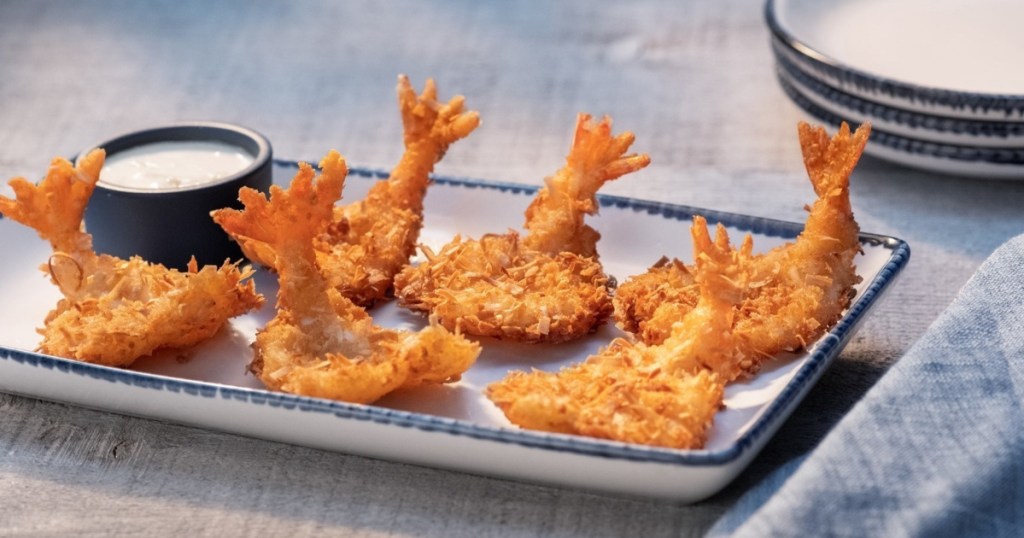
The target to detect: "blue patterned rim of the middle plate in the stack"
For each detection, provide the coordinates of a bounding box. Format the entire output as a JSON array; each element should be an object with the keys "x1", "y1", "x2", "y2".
[{"x1": 772, "y1": 44, "x2": 1024, "y2": 140}]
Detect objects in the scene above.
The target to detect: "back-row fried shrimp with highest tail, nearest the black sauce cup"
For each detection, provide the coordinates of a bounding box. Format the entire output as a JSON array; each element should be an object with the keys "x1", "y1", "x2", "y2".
[{"x1": 224, "y1": 75, "x2": 480, "y2": 306}]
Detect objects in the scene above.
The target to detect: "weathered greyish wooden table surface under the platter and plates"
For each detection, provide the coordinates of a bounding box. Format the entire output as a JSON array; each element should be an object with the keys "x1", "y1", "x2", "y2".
[{"x1": 0, "y1": 0, "x2": 1024, "y2": 537}]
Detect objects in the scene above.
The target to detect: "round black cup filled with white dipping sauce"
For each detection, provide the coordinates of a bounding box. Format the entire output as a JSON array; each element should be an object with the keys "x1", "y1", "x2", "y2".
[{"x1": 78, "y1": 122, "x2": 272, "y2": 270}]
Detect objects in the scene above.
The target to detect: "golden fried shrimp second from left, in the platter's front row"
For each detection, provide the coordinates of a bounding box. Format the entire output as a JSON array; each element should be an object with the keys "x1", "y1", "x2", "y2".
[{"x1": 212, "y1": 152, "x2": 480, "y2": 403}]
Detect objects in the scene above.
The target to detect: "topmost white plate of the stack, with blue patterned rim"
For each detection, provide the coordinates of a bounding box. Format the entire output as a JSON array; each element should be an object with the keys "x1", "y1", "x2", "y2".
[{"x1": 765, "y1": 0, "x2": 1024, "y2": 121}]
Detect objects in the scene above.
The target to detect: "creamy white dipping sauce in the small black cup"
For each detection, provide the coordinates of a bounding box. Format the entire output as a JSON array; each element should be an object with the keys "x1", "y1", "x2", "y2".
[{"x1": 99, "y1": 140, "x2": 256, "y2": 190}]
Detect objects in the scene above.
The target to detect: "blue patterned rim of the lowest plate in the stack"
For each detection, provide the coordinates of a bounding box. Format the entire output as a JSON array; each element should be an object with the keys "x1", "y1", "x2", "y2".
[{"x1": 777, "y1": 68, "x2": 1024, "y2": 166}]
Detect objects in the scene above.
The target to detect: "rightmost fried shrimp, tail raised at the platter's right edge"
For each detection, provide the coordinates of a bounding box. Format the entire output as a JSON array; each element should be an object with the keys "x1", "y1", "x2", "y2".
[{"x1": 615, "y1": 123, "x2": 870, "y2": 373}]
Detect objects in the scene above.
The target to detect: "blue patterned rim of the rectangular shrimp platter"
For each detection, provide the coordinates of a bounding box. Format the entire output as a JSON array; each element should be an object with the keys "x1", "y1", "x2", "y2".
[{"x1": 0, "y1": 160, "x2": 910, "y2": 466}]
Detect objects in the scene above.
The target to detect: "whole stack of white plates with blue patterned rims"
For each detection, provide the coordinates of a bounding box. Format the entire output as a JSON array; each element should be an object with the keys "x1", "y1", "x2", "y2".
[{"x1": 765, "y1": 0, "x2": 1024, "y2": 179}]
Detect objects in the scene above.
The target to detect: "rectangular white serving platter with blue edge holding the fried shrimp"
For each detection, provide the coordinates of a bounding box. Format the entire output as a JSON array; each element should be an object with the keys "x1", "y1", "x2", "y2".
[{"x1": 0, "y1": 161, "x2": 909, "y2": 502}]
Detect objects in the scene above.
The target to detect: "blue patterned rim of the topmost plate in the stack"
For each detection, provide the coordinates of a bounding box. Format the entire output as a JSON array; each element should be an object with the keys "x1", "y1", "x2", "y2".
[{"x1": 765, "y1": 0, "x2": 1024, "y2": 119}]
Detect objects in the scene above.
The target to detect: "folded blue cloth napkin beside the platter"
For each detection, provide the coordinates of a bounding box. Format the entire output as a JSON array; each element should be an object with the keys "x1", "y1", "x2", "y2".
[{"x1": 710, "y1": 236, "x2": 1024, "y2": 537}]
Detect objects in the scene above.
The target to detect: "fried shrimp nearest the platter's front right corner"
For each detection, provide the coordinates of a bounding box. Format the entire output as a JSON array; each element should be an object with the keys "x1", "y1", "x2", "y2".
[{"x1": 486, "y1": 217, "x2": 749, "y2": 449}]
